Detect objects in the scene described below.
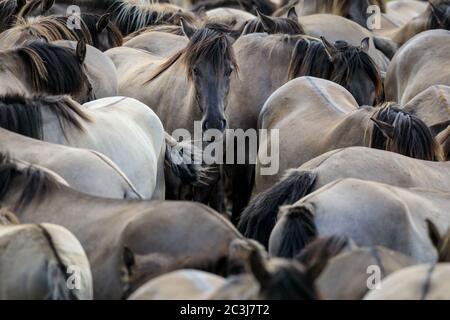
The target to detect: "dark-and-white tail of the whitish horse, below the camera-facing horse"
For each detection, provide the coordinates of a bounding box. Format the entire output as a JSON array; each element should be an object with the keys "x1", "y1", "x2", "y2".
[{"x1": 164, "y1": 132, "x2": 202, "y2": 184}]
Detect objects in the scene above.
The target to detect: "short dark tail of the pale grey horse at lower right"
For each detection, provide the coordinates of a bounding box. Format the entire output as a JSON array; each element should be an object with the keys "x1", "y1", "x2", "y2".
[{"x1": 270, "y1": 204, "x2": 317, "y2": 258}]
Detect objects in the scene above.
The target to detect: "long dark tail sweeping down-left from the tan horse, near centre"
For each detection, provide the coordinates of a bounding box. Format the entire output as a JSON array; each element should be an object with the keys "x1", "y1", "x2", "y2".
[{"x1": 238, "y1": 170, "x2": 317, "y2": 247}]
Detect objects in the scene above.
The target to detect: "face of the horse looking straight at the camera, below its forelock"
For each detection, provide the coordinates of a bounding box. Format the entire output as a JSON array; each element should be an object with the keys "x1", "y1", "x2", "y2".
[{"x1": 192, "y1": 60, "x2": 233, "y2": 132}]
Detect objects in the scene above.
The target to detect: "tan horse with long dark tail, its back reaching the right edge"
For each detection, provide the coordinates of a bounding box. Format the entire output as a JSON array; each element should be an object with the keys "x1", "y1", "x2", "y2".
[{"x1": 238, "y1": 147, "x2": 450, "y2": 245}]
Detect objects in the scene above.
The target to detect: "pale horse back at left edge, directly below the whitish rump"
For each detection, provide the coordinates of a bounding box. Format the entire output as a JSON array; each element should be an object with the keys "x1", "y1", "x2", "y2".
[{"x1": 0, "y1": 128, "x2": 142, "y2": 199}]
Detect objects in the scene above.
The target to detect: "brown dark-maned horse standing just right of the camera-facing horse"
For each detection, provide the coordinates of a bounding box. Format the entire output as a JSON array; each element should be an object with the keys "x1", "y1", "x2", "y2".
[{"x1": 225, "y1": 33, "x2": 381, "y2": 222}]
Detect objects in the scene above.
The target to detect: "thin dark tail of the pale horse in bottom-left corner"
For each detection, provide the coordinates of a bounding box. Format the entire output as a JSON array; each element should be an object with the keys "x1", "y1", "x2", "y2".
[{"x1": 37, "y1": 224, "x2": 79, "y2": 300}]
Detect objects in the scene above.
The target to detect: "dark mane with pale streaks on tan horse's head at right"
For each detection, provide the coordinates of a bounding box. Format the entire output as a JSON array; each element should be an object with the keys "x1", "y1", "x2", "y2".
[{"x1": 370, "y1": 103, "x2": 443, "y2": 161}]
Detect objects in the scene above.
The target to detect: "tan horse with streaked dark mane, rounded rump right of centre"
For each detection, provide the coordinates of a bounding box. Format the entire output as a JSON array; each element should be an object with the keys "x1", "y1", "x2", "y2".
[{"x1": 254, "y1": 77, "x2": 442, "y2": 194}]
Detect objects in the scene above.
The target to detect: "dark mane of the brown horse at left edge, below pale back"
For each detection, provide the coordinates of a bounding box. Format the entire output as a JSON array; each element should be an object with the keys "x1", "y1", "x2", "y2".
[{"x1": 0, "y1": 153, "x2": 59, "y2": 212}]
